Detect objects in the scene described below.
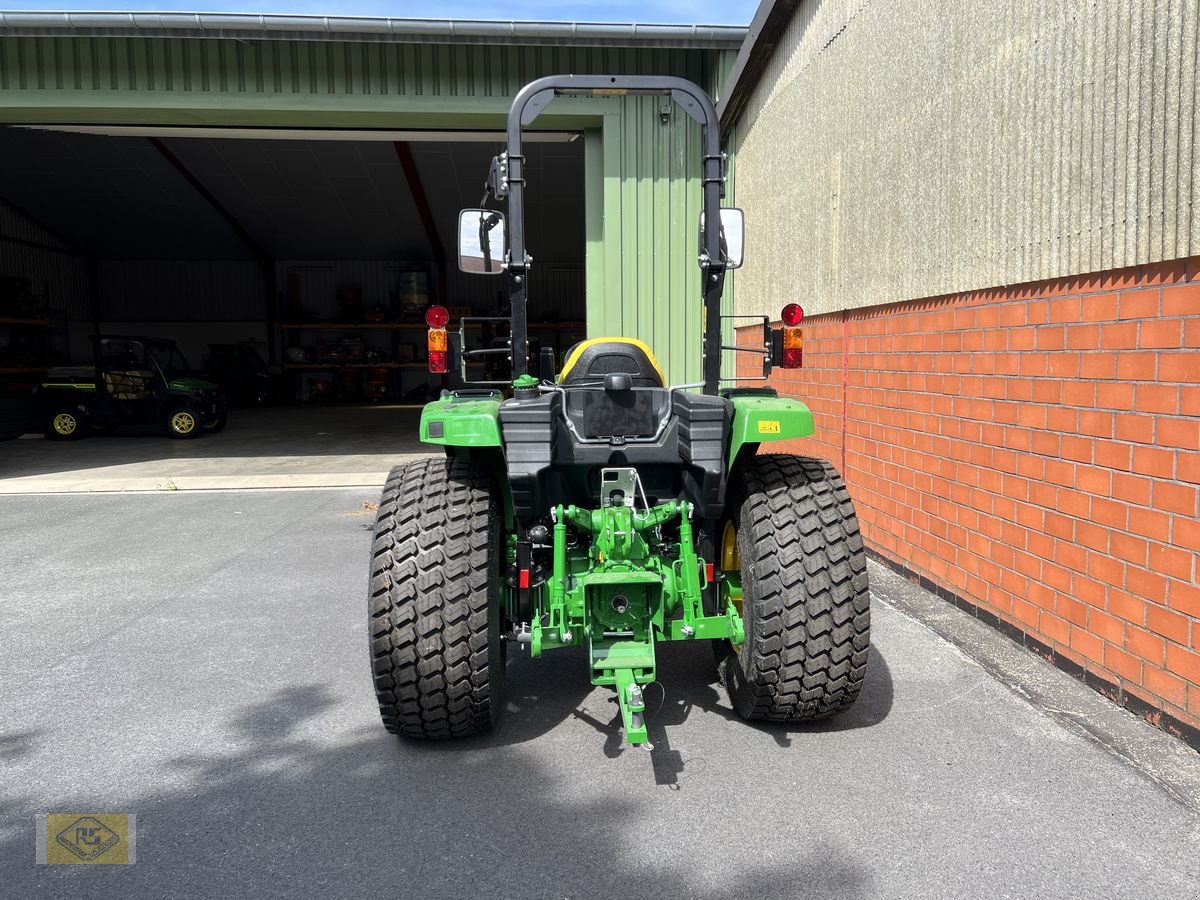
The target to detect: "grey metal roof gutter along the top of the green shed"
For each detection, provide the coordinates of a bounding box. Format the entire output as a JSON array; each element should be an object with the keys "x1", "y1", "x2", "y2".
[{"x1": 0, "y1": 11, "x2": 748, "y2": 50}]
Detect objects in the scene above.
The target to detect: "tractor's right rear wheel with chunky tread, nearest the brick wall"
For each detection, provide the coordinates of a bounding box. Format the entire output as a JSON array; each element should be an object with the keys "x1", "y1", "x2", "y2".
[{"x1": 720, "y1": 455, "x2": 871, "y2": 721}]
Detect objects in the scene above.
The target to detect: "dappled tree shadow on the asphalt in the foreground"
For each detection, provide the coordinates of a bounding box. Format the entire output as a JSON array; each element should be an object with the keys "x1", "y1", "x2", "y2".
[{"x1": 0, "y1": 681, "x2": 872, "y2": 900}]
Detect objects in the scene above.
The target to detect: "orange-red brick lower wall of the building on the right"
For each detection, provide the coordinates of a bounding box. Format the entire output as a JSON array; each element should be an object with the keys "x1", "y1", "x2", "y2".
[{"x1": 740, "y1": 257, "x2": 1200, "y2": 730}]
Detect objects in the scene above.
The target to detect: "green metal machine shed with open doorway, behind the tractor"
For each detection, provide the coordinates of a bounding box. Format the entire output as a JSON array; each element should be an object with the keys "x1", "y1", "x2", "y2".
[{"x1": 0, "y1": 12, "x2": 745, "y2": 420}]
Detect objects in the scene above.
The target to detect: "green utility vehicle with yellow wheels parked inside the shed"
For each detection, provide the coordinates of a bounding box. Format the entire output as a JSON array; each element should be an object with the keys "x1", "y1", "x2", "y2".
[{"x1": 37, "y1": 335, "x2": 228, "y2": 440}]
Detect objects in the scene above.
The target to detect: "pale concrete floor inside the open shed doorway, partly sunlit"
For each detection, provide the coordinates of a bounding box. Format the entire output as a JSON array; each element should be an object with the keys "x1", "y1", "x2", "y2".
[{"x1": 0, "y1": 404, "x2": 428, "y2": 494}]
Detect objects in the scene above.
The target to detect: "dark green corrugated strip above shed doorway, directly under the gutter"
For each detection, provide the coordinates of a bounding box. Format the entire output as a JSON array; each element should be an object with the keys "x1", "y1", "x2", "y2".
[{"x1": 0, "y1": 37, "x2": 715, "y2": 100}]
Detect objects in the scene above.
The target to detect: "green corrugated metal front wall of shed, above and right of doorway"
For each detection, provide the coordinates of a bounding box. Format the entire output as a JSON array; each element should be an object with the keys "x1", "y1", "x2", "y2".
[{"x1": 0, "y1": 37, "x2": 734, "y2": 383}]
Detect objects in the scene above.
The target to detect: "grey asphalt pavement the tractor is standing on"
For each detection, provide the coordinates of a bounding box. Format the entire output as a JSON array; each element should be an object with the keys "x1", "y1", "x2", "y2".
[{"x1": 0, "y1": 488, "x2": 1200, "y2": 898}]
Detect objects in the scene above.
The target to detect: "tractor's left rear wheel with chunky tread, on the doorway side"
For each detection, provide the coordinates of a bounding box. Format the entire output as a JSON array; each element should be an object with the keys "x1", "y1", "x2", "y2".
[{"x1": 367, "y1": 458, "x2": 505, "y2": 739}]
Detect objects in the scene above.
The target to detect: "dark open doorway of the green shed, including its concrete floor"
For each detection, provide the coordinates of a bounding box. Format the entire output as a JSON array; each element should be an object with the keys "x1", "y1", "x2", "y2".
[{"x1": 0, "y1": 126, "x2": 586, "y2": 490}]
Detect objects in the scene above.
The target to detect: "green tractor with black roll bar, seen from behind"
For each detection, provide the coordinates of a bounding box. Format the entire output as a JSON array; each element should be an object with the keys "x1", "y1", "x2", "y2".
[{"x1": 368, "y1": 76, "x2": 870, "y2": 745}]
